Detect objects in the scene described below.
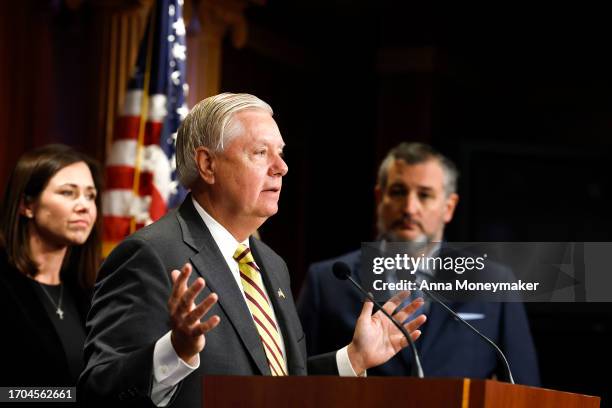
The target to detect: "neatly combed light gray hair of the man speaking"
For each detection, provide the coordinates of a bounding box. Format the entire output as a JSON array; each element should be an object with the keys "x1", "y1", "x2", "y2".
[{"x1": 176, "y1": 93, "x2": 274, "y2": 187}]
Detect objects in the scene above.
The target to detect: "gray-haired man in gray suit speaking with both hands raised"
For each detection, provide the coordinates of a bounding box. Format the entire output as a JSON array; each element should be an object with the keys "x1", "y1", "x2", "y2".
[{"x1": 78, "y1": 94, "x2": 425, "y2": 407}]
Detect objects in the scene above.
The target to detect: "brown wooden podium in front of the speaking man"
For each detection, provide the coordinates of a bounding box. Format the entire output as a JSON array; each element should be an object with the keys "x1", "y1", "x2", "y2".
[{"x1": 202, "y1": 376, "x2": 600, "y2": 408}]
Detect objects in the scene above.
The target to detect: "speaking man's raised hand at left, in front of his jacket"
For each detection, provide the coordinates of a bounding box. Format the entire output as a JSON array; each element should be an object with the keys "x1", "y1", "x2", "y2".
[{"x1": 168, "y1": 263, "x2": 221, "y2": 364}]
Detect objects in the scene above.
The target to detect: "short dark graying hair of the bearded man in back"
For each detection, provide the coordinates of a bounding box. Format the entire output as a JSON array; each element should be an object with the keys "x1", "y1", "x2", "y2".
[{"x1": 378, "y1": 142, "x2": 459, "y2": 196}]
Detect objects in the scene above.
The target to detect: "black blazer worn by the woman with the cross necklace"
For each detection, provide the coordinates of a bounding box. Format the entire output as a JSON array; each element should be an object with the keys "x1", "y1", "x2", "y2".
[{"x1": 0, "y1": 249, "x2": 88, "y2": 386}]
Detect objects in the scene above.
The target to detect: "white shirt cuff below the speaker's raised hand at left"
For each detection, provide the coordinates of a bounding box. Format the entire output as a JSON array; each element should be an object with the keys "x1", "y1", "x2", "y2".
[{"x1": 151, "y1": 331, "x2": 200, "y2": 407}]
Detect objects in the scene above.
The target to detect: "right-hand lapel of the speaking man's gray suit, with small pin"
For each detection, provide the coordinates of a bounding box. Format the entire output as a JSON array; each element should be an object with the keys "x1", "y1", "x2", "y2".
[{"x1": 250, "y1": 239, "x2": 306, "y2": 374}]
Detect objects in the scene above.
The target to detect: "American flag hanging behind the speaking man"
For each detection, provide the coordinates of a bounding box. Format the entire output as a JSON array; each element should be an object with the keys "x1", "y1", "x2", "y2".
[{"x1": 102, "y1": 0, "x2": 188, "y2": 256}]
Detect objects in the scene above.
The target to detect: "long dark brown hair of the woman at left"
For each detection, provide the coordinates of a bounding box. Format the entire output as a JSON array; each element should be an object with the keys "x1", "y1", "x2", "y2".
[{"x1": 0, "y1": 144, "x2": 102, "y2": 288}]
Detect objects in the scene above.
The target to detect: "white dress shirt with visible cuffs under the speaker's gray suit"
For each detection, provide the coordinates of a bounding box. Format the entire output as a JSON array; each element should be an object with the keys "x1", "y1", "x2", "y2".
[{"x1": 151, "y1": 197, "x2": 357, "y2": 407}]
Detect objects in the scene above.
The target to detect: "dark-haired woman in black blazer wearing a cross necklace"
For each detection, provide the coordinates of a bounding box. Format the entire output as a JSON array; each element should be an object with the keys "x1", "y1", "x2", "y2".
[{"x1": 0, "y1": 145, "x2": 101, "y2": 387}]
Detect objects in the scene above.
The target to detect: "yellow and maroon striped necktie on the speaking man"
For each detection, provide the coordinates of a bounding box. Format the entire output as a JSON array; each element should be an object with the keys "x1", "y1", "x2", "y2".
[{"x1": 234, "y1": 244, "x2": 287, "y2": 375}]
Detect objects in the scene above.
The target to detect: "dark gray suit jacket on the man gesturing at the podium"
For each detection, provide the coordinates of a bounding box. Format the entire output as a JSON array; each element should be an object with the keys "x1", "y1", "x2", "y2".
[{"x1": 79, "y1": 196, "x2": 337, "y2": 407}]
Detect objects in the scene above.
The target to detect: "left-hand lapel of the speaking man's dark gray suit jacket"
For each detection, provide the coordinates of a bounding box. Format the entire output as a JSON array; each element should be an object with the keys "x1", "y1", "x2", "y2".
[{"x1": 177, "y1": 196, "x2": 270, "y2": 374}]
